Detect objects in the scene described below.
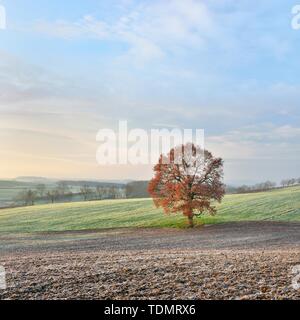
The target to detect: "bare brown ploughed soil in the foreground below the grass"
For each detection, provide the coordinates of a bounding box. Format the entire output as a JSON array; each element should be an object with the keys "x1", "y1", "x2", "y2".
[{"x1": 0, "y1": 222, "x2": 300, "y2": 299}]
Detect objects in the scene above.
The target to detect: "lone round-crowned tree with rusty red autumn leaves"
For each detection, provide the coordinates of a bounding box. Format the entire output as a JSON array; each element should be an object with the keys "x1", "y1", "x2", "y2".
[{"x1": 148, "y1": 143, "x2": 225, "y2": 227}]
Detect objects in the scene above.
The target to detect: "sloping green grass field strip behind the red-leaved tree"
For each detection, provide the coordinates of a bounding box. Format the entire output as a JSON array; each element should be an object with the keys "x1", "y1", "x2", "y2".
[{"x1": 0, "y1": 187, "x2": 300, "y2": 233}]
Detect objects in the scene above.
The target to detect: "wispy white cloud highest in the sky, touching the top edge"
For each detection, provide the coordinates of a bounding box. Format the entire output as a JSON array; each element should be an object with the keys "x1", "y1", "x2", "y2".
[{"x1": 34, "y1": 0, "x2": 214, "y2": 61}]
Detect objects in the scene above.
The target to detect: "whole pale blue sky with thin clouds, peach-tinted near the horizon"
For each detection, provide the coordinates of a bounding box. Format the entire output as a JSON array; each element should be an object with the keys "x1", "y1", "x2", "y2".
[{"x1": 0, "y1": 0, "x2": 300, "y2": 184}]
